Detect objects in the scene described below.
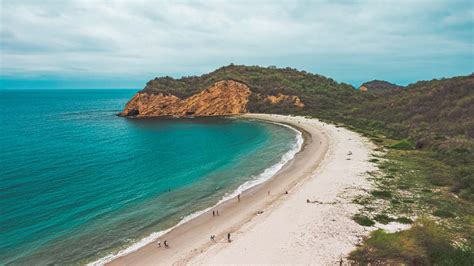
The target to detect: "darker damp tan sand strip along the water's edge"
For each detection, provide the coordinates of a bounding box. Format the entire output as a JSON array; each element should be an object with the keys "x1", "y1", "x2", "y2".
[{"x1": 103, "y1": 114, "x2": 327, "y2": 265}]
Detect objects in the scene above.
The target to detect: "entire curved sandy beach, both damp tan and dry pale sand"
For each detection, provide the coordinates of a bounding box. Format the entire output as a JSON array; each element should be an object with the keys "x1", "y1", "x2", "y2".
[{"x1": 105, "y1": 114, "x2": 373, "y2": 265}]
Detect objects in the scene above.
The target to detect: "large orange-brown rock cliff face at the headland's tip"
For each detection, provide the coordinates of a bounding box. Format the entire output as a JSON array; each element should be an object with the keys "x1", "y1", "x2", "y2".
[{"x1": 119, "y1": 80, "x2": 251, "y2": 117}]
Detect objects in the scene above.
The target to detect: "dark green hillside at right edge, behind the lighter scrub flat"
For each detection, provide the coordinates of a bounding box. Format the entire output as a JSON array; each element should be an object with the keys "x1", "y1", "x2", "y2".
[{"x1": 340, "y1": 75, "x2": 474, "y2": 201}]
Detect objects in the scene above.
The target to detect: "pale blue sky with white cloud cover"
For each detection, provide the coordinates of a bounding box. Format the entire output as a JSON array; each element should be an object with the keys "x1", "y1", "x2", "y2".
[{"x1": 0, "y1": 0, "x2": 474, "y2": 89}]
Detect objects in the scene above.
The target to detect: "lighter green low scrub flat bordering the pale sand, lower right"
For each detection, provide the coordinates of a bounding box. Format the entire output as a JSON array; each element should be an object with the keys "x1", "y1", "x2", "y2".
[{"x1": 350, "y1": 139, "x2": 474, "y2": 265}]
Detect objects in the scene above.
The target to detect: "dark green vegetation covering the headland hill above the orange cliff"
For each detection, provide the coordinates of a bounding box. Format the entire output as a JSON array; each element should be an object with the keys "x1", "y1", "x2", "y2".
[{"x1": 143, "y1": 65, "x2": 364, "y2": 117}]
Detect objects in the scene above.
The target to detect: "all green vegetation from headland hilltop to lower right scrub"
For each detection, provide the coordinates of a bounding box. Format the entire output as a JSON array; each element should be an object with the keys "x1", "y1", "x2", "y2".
[{"x1": 144, "y1": 65, "x2": 474, "y2": 265}]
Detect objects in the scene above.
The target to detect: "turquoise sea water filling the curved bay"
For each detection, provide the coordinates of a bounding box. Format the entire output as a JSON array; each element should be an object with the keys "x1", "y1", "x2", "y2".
[{"x1": 0, "y1": 90, "x2": 295, "y2": 265}]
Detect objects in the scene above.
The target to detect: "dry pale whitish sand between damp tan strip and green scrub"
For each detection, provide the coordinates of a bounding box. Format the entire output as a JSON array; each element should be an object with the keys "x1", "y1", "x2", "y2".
[{"x1": 186, "y1": 115, "x2": 377, "y2": 265}]
